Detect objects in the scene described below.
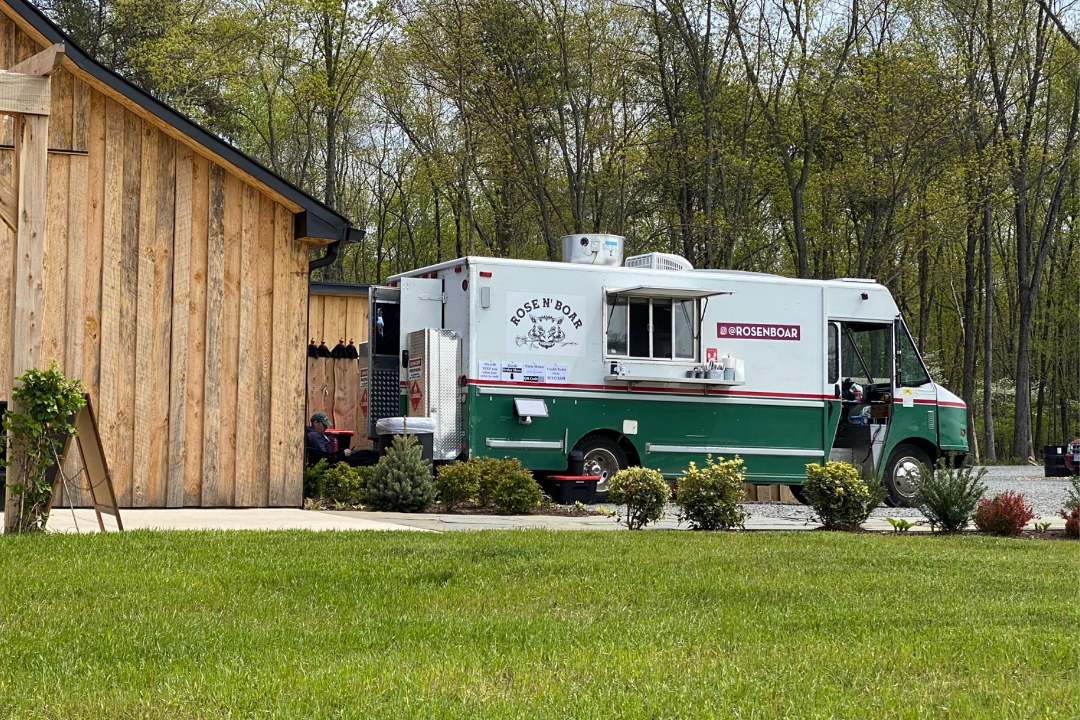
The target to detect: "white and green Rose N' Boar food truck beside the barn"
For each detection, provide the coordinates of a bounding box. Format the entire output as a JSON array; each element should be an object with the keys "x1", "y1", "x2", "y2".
[{"x1": 361, "y1": 234, "x2": 968, "y2": 504}]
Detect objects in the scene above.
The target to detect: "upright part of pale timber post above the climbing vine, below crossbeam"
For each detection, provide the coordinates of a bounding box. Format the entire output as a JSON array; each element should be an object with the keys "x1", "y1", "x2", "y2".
[{"x1": 3, "y1": 112, "x2": 49, "y2": 532}]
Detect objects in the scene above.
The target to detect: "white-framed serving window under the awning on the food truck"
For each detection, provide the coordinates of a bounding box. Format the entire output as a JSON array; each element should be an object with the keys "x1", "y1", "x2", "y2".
[{"x1": 607, "y1": 295, "x2": 699, "y2": 362}]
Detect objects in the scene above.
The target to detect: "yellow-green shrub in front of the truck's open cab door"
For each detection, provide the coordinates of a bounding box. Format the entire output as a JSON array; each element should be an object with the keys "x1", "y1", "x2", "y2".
[{"x1": 802, "y1": 461, "x2": 886, "y2": 530}]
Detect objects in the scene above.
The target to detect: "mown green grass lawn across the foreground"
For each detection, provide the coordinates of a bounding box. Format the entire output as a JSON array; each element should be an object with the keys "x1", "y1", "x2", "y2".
[{"x1": 0, "y1": 531, "x2": 1080, "y2": 720}]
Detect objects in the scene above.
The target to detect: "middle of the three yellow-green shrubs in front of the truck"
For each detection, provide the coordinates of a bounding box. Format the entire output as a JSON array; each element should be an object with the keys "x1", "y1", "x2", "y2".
[{"x1": 677, "y1": 456, "x2": 750, "y2": 530}]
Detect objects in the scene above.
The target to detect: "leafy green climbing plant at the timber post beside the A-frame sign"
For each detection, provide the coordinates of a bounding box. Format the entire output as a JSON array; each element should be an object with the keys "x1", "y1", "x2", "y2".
[{"x1": 3, "y1": 363, "x2": 86, "y2": 533}]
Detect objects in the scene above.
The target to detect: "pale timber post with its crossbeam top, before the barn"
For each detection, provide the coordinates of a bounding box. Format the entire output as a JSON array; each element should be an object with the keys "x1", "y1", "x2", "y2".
[{"x1": 0, "y1": 45, "x2": 64, "y2": 532}]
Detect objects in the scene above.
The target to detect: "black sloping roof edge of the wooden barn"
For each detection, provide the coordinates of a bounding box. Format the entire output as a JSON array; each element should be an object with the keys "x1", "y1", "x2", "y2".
[{"x1": 4, "y1": 0, "x2": 355, "y2": 242}]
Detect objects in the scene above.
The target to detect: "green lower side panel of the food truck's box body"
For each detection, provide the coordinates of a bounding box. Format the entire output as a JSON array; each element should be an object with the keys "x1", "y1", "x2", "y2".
[{"x1": 464, "y1": 385, "x2": 836, "y2": 484}]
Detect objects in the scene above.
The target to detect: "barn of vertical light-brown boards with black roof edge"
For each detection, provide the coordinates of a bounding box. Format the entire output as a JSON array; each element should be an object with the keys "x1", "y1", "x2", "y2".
[{"x1": 0, "y1": 0, "x2": 359, "y2": 507}]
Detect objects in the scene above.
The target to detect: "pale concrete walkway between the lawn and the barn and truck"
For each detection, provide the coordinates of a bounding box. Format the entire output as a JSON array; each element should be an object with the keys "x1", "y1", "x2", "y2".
[{"x1": 49, "y1": 507, "x2": 1065, "y2": 532}]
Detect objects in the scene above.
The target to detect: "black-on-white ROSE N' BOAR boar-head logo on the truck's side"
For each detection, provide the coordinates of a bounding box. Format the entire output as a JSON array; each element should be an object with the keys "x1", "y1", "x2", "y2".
[{"x1": 507, "y1": 293, "x2": 584, "y2": 355}]
